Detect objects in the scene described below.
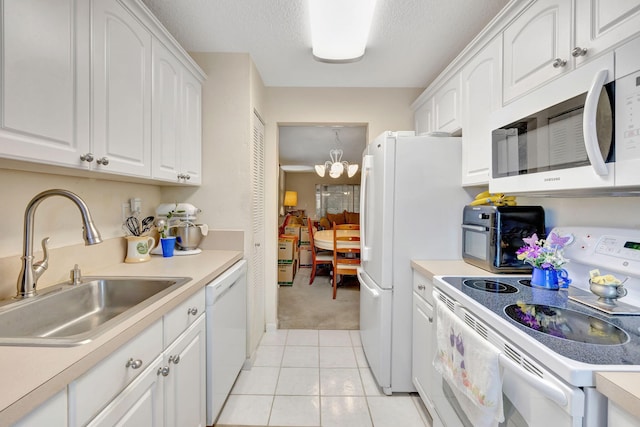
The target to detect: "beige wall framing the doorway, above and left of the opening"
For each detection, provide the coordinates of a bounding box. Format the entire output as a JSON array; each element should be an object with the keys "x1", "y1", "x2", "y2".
[{"x1": 265, "y1": 87, "x2": 422, "y2": 329}]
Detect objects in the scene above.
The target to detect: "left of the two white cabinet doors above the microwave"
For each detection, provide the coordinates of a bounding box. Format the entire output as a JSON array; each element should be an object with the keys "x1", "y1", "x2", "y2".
[{"x1": 503, "y1": 0, "x2": 582, "y2": 103}]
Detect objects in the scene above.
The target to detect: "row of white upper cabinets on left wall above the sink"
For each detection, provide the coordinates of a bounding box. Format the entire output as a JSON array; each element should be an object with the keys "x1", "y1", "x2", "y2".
[{"x1": 0, "y1": 0, "x2": 206, "y2": 185}]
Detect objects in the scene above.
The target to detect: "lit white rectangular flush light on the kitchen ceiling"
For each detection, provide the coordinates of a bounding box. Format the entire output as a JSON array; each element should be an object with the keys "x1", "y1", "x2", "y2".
[{"x1": 309, "y1": 0, "x2": 376, "y2": 63}]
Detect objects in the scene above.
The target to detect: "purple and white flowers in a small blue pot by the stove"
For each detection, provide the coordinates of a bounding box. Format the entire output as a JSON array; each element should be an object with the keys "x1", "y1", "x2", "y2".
[{"x1": 516, "y1": 233, "x2": 572, "y2": 290}]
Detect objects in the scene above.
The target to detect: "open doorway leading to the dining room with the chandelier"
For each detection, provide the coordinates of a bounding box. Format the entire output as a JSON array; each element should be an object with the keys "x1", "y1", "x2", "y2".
[{"x1": 278, "y1": 123, "x2": 368, "y2": 329}]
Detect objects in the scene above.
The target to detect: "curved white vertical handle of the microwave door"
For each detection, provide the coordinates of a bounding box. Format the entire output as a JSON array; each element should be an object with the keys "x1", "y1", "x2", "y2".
[{"x1": 582, "y1": 70, "x2": 609, "y2": 176}]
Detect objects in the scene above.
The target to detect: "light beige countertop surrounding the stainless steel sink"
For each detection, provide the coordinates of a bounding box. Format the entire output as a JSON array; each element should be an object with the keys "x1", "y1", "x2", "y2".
[{"x1": 0, "y1": 250, "x2": 243, "y2": 425}]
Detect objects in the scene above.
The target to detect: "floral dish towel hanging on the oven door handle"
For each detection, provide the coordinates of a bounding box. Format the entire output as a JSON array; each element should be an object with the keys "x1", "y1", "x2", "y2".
[{"x1": 433, "y1": 298, "x2": 504, "y2": 427}]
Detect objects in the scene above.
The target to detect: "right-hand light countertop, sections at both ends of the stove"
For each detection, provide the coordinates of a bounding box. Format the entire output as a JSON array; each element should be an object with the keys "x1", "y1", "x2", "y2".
[{"x1": 411, "y1": 260, "x2": 640, "y2": 418}]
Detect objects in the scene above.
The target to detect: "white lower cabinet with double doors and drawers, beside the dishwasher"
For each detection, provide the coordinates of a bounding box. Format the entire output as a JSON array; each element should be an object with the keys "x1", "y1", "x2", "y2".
[{"x1": 68, "y1": 288, "x2": 206, "y2": 427}]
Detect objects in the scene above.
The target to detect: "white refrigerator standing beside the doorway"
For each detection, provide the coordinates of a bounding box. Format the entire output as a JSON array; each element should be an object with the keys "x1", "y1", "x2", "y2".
[{"x1": 358, "y1": 132, "x2": 471, "y2": 394}]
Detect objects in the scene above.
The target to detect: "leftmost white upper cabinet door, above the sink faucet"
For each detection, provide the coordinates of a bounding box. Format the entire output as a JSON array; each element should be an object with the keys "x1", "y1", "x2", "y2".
[{"x1": 0, "y1": 0, "x2": 89, "y2": 166}]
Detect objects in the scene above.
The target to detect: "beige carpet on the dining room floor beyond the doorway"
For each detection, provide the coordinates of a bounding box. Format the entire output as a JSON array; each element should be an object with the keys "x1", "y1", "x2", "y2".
[{"x1": 278, "y1": 267, "x2": 360, "y2": 329}]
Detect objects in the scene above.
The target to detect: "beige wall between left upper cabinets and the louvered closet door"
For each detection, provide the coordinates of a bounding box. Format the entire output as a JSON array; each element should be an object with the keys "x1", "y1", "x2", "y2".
[{"x1": 179, "y1": 53, "x2": 265, "y2": 353}]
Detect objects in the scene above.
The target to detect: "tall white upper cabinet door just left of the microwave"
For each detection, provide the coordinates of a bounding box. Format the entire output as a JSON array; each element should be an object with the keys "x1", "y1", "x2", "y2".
[{"x1": 460, "y1": 37, "x2": 502, "y2": 185}]
